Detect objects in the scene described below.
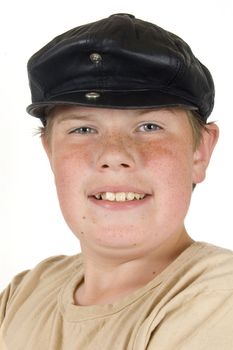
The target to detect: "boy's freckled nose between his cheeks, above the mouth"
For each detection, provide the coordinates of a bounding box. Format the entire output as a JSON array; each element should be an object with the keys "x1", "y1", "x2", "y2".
[{"x1": 97, "y1": 135, "x2": 135, "y2": 171}]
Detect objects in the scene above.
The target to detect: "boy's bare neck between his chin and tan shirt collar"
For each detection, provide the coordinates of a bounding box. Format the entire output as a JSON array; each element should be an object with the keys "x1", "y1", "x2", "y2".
[{"x1": 74, "y1": 231, "x2": 193, "y2": 306}]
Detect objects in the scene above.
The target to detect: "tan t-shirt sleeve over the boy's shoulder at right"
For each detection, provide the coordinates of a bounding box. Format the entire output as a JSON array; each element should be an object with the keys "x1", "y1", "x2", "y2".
[{"x1": 145, "y1": 242, "x2": 233, "y2": 350}]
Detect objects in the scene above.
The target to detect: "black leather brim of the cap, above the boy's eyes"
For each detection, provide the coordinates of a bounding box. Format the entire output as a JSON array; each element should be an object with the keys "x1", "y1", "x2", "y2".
[{"x1": 27, "y1": 90, "x2": 198, "y2": 119}]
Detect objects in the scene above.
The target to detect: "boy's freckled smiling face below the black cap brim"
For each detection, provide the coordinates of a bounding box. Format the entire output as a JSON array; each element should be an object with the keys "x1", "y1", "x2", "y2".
[{"x1": 43, "y1": 107, "x2": 218, "y2": 254}]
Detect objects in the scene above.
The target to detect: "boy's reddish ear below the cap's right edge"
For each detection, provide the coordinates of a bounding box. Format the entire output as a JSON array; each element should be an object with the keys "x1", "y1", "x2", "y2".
[{"x1": 193, "y1": 123, "x2": 219, "y2": 184}]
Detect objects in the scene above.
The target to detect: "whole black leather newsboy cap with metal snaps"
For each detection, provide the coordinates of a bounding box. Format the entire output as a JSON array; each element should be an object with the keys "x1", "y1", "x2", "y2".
[{"x1": 27, "y1": 14, "x2": 214, "y2": 121}]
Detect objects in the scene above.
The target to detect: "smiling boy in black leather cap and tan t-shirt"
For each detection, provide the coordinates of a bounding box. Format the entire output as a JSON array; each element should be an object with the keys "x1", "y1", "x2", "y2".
[{"x1": 0, "y1": 14, "x2": 233, "y2": 350}]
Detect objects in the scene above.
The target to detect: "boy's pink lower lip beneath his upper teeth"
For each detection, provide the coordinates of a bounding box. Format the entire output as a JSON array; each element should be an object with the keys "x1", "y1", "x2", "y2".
[{"x1": 89, "y1": 195, "x2": 151, "y2": 210}]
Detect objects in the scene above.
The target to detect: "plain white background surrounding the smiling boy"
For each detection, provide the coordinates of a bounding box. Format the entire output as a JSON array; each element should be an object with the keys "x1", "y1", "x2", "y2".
[{"x1": 0, "y1": 0, "x2": 233, "y2": 289}]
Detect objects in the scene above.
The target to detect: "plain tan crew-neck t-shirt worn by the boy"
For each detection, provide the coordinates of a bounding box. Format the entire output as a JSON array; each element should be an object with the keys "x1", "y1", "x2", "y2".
[{"x1": 0, "y1": 242, "x2": 233, "y2": 350}]
